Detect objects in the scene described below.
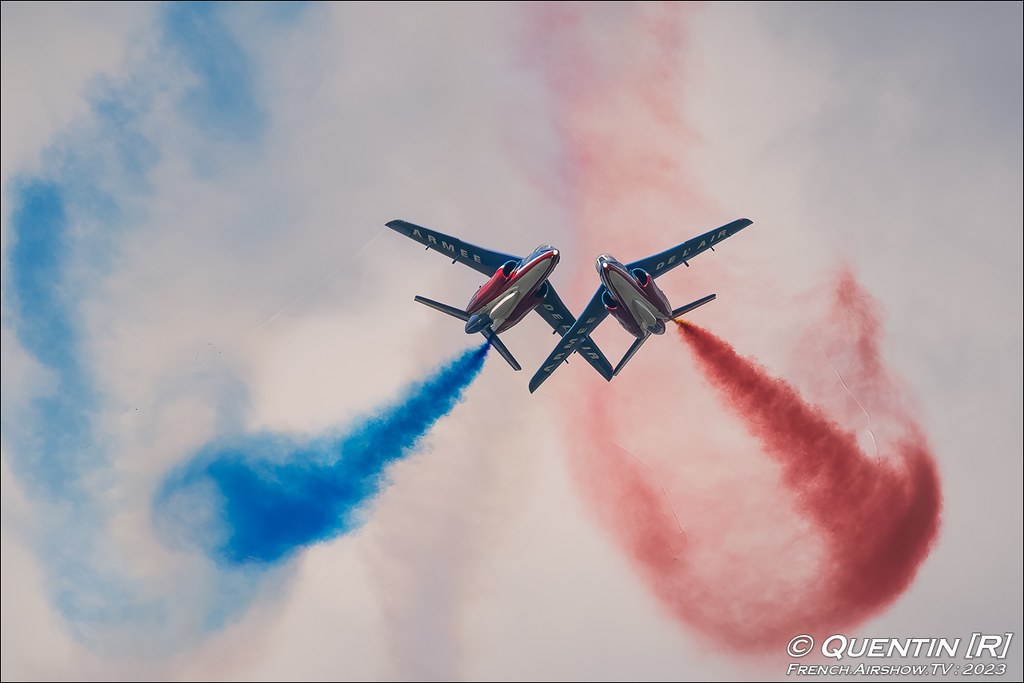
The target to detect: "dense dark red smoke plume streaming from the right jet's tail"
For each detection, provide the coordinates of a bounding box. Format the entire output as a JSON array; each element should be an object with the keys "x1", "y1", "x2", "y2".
[{"x1": 679, "y1": 313, "x2": 941, "y2": 644}]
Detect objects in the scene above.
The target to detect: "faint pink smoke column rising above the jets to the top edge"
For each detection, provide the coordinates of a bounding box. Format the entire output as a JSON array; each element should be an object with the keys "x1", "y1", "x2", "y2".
[{"x1": 524, "y1": 3, "x2": 702, "y2": 274}]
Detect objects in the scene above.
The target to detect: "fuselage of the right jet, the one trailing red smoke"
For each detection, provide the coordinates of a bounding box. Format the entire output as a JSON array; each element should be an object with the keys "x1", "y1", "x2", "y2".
[{"x1": 596, "y1": 254, "x2": 672, "y2": 339}]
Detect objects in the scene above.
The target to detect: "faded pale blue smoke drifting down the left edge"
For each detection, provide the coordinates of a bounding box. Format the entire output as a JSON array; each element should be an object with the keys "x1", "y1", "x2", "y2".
[{"x1": 0, "y1": 3, "x2": 307, "y2": 643}]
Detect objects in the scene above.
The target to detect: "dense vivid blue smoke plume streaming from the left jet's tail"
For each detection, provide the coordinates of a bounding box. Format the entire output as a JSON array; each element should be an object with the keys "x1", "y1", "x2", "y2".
[{"x1": 154, "y1": 344, "x2": 488, "y2": 565}]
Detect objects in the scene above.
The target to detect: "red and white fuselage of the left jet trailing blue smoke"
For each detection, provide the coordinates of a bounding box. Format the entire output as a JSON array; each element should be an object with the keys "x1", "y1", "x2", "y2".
[{"x1": 466, "y1": 245, "x2": 559, "y2": 334}]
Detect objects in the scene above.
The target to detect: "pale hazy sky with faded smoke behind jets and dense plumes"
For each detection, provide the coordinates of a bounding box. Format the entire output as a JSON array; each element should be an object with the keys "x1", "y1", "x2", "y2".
[{"x1": 0, "y1": 2, "x2": 1024, "y2": 680}]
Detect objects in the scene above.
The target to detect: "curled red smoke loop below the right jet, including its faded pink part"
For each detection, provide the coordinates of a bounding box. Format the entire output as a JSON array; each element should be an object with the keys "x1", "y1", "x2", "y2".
[{"x1": 573, "y1": 273, "x2": 941, "y2": 652}]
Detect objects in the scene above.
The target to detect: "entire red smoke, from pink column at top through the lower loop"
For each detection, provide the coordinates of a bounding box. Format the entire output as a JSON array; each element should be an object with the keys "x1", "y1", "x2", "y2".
[{"x1": 528, "y1": 4, "x2": 940, "y2": 652}]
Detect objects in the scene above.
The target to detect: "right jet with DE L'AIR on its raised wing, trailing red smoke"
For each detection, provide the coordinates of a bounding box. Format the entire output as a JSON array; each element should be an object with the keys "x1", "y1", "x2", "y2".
[{"x1": 529, "y1": 218, "x2": 752, "y2": 393}]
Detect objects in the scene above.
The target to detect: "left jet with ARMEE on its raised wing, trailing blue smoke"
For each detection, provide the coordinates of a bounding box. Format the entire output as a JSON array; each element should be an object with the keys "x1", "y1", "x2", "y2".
[{"x1": 387, "y1": 220, "x2": 612, "y2": 380}]
